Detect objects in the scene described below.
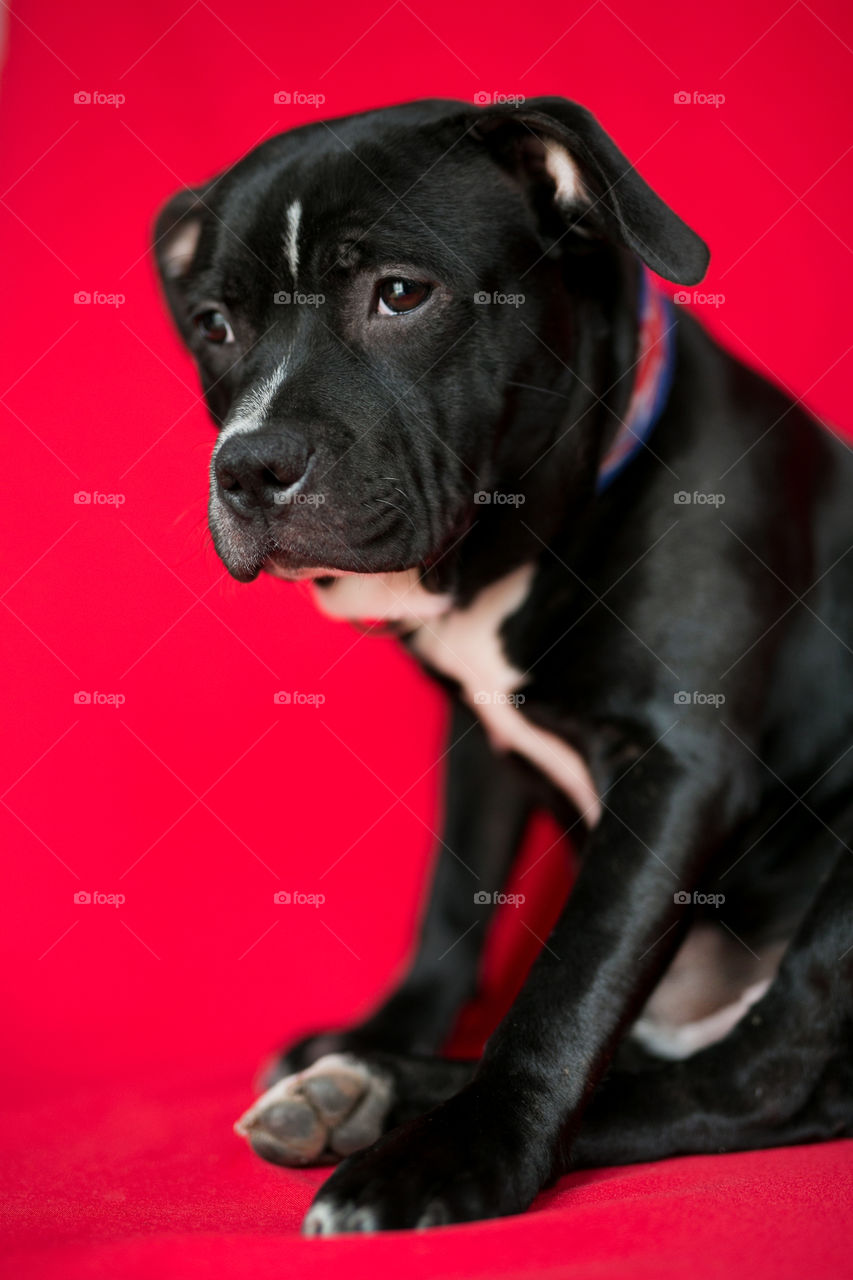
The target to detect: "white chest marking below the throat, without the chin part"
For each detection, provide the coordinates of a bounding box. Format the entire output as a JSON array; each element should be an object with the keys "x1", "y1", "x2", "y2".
[{"x1": 411, "y1": 564, "x2": 601, "y2": 827}]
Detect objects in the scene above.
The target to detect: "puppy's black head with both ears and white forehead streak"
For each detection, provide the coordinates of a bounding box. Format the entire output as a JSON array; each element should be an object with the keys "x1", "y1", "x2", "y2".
[{"x1": 155, "y1": 99, "x2": 707, "y2": 581}]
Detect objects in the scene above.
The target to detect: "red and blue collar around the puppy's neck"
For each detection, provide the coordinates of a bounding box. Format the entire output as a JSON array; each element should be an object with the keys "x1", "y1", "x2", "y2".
[{"x1": 596, "y1": 268, "x2": 678, "y2": 493}]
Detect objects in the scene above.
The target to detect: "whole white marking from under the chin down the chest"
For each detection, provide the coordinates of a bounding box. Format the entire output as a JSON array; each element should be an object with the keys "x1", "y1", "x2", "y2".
[{"x1": 314, "y1": 564, "x2": 601, "y2": 827}]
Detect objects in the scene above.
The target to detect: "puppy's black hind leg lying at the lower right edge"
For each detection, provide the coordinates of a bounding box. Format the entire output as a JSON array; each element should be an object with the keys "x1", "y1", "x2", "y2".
[{"x1": 556, "y1": 841, "x2": 853, "y2": 1172}]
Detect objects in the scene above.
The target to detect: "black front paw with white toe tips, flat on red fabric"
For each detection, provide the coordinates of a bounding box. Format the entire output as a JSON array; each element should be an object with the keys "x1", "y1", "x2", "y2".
[{"x1": 302, "y1": 1089, "x2": 537, "y2": 1235}]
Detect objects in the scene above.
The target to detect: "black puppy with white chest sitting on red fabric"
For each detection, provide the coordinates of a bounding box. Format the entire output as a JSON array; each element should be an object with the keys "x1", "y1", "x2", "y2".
[{"x1": 156, "y1": 99, "x2": 853, "y2": 1233}]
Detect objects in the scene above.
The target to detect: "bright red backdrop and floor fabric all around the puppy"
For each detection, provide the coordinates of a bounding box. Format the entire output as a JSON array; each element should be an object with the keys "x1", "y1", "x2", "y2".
[{"x1": 0, "y1": 0, "x2": 853, "y2": 1276}]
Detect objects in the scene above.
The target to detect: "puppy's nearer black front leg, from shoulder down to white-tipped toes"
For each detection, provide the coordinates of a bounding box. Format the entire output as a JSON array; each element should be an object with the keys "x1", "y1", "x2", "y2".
[{"x1": 305, "y1": 735, "x2": 731, "y2": 1234}]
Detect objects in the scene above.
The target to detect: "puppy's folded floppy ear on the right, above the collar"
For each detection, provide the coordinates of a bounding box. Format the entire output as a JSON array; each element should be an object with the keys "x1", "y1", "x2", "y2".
[{"x1": 476, "y1": 97, "x2": 710, "y2": 284}]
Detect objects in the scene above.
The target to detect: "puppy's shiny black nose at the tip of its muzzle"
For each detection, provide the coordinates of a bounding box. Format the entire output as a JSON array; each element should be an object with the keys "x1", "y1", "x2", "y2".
[{"x1": 214, "y1": 431, "x2": 310, "y2": 517}]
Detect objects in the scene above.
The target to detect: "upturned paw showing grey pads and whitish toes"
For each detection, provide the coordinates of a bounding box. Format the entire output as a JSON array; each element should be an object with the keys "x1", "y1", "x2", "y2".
[{"x1": 234, "y1": 1053, "x2": 393, "y2": 1165}]
